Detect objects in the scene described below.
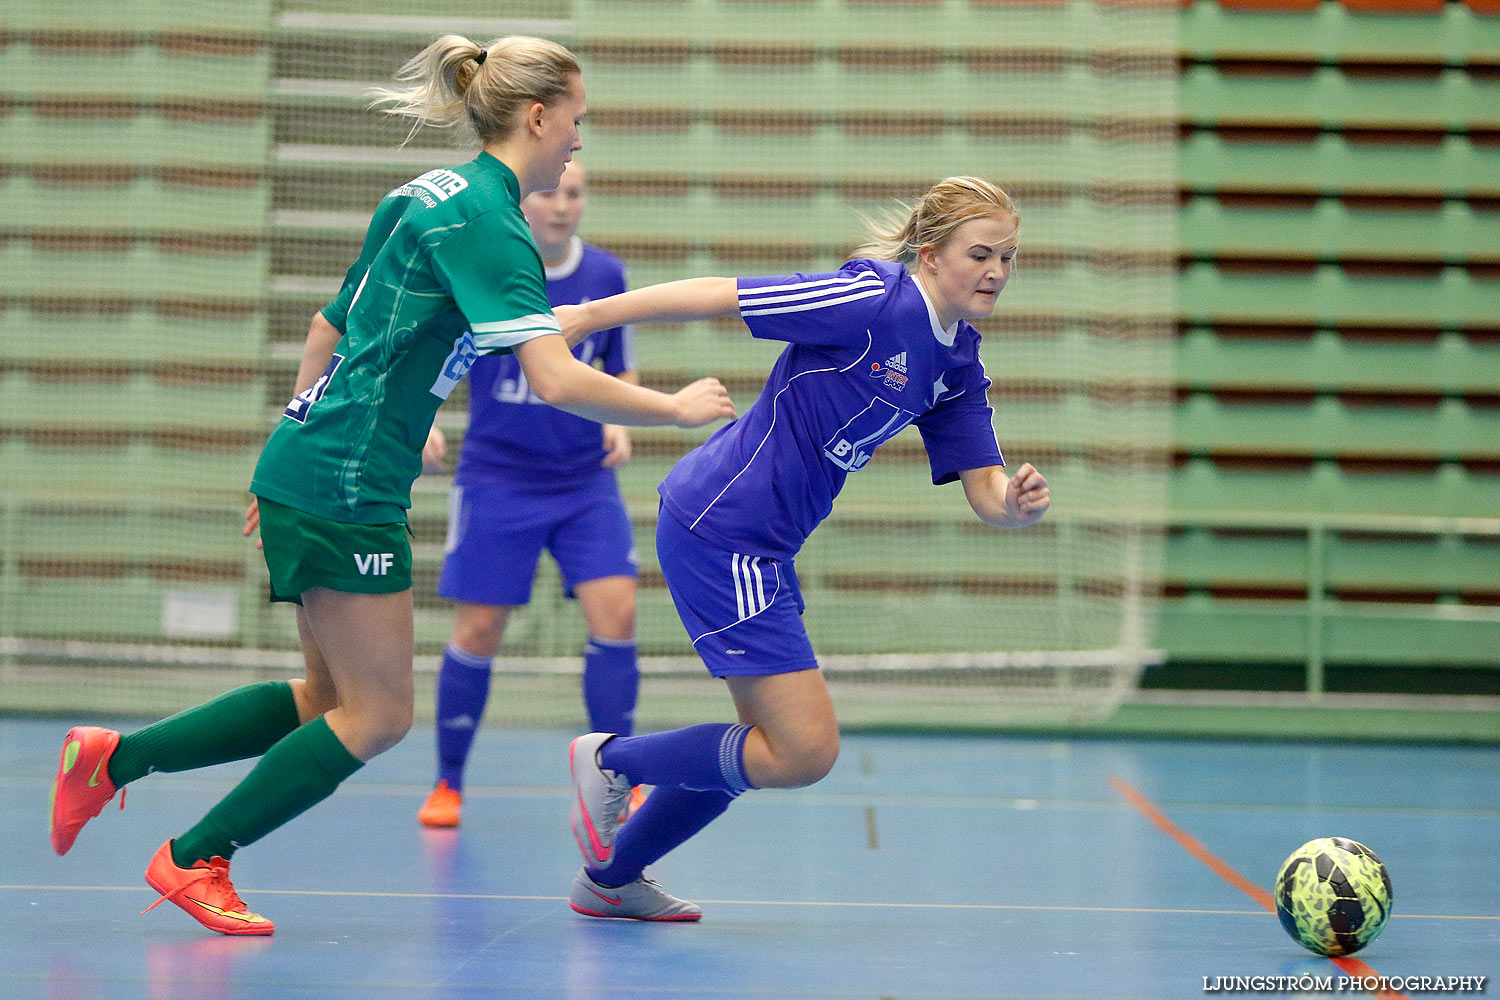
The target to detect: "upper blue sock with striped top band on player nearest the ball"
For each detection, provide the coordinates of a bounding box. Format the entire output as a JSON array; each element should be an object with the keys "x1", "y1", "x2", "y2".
[{"x1": 599, "y1": 723, "x2": 755, "y2": 801}]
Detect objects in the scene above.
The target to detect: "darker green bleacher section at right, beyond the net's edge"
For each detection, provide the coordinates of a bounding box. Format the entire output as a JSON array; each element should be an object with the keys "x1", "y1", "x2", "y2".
[{"x1": 1161, "y1": 0, "x2": 1500, "y2": 691}]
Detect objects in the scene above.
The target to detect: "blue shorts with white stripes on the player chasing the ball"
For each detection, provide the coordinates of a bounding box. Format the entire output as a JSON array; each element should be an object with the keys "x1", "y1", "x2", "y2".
[{"x1": 657, "y1": 510, "x2": 818, "y2": 678}]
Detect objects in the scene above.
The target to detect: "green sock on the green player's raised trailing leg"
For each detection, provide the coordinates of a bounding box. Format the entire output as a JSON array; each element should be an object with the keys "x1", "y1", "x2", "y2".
[{"x1": 110, "y1": 681, "x2": 300, "y2": 787}]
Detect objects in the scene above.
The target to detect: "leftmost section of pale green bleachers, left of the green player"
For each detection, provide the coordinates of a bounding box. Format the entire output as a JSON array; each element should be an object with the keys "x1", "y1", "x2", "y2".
[{"x1": 0, "y1": 15, "x2": 272, "y2": 653}]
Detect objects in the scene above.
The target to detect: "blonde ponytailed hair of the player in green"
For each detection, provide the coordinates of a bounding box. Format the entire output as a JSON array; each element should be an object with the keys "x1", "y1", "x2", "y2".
[{"x1": 371, "y1": 34, "x2": 581, "y2": 145}]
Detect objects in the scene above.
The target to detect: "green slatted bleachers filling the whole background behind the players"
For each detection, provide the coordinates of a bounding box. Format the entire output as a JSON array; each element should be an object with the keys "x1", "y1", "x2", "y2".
[{"x1": 0, "y1": 0, "x2": 1500, "y2": 728}]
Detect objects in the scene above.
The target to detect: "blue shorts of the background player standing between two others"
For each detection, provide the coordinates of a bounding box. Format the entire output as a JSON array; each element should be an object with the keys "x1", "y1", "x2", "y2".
[{"x1": 438, "y1": 469, "x2": 639, "y2": 607}]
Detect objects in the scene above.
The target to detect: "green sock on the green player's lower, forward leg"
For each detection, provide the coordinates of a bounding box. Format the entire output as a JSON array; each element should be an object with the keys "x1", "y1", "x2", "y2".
[{"x1": 173, "y1": 715, "x2": 365, "y2": 868}]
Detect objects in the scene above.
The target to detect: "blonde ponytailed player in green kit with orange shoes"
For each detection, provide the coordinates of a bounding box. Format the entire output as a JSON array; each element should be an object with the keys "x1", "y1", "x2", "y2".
[{"x1": 51, "y1": 34, "x2": 734, "y2": 934}]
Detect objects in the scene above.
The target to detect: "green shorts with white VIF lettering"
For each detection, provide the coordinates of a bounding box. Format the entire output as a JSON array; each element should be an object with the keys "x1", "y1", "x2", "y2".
[{"x1": 258, "y1": 496, "x2": 411, "y2": 604}]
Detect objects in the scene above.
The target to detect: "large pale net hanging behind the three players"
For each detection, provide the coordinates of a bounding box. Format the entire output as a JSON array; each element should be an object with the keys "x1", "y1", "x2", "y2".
[{"x1": 0, "y1": 0, "x2": 1176, "y2": 727}]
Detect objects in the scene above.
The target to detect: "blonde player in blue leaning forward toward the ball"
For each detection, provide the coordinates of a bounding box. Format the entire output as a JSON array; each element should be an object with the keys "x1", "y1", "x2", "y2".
[{"x1": 558, "y1": 177, "x2": 1050, "y2": 921}]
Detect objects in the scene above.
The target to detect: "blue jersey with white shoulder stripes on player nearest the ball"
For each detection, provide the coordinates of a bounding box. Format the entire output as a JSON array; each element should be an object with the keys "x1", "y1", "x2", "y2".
[{"x1": 660, "y1": 261, "x2": 1005, "y2": 559}]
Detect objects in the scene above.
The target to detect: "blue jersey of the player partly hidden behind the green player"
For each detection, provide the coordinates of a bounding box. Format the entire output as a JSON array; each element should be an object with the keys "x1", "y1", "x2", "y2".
[{"x1": 455, "y1": 237, "x2": 636, "y2": 486}]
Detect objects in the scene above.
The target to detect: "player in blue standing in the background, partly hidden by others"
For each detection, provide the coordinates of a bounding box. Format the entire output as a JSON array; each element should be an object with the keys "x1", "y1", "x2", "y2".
[{"x1": 417, "y1": 160, "x2": 641, "y2": 826}]
